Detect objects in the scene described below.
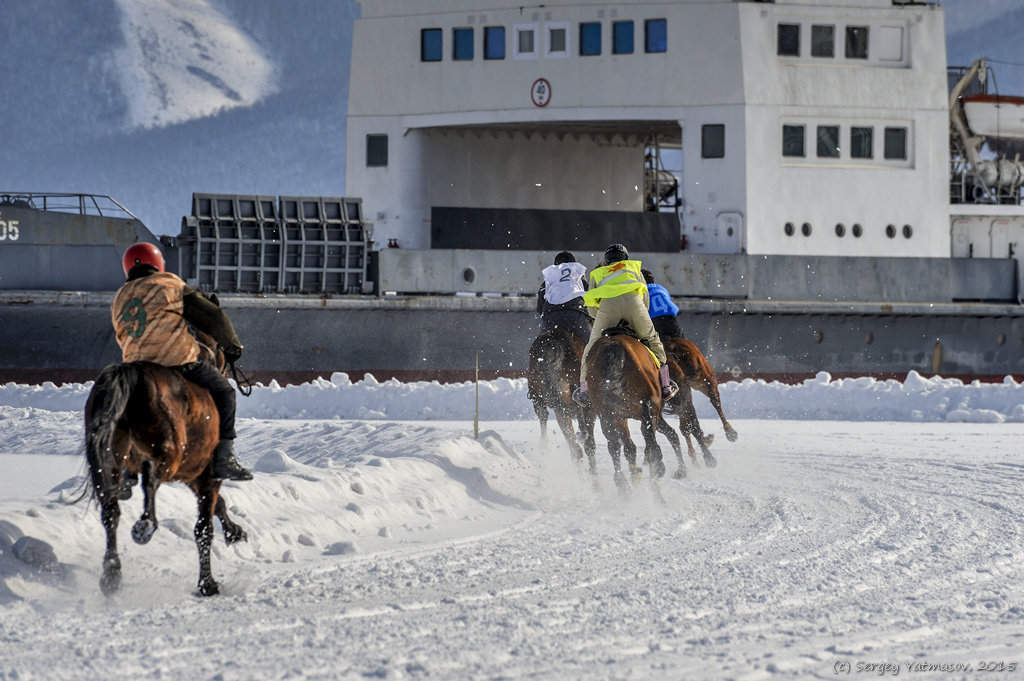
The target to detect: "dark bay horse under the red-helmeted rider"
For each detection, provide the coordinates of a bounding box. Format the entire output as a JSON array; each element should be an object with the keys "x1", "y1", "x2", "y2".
[{"x1": 85, "y1": 339, "x2": 246, "y2": 596}]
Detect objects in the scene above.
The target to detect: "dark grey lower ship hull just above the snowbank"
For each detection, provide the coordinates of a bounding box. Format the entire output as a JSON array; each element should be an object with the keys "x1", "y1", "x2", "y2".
[{"x1": 0, "y1": 293, "x2": 1024, "y2": 383}]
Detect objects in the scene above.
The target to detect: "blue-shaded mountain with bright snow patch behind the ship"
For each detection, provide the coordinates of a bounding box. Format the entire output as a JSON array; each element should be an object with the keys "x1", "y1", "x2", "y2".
[{"x1": 0, "y1": 0, "x2": 1024, "y2": 235}]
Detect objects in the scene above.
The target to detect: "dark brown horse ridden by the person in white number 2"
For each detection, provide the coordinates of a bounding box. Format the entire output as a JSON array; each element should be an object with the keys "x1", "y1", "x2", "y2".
[{"x1": 526, "y1": 329, "x2": 597, "y2": 474}]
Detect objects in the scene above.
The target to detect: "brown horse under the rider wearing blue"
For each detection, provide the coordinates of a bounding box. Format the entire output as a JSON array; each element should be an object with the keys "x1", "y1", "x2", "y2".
[{"x1": 662, "y1": 338, "x2": 739, "y2": 467}]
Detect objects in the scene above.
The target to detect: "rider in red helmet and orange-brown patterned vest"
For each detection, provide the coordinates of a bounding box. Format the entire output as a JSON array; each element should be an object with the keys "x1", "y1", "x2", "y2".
[{"x1": 111, "y1": 243, "x2": 253, "y2": 480}]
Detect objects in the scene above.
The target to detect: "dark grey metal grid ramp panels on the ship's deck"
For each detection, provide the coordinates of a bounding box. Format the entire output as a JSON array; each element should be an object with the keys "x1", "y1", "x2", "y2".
[{"x1": 178, "y1": 194, "x2": 370, "y2": 294}]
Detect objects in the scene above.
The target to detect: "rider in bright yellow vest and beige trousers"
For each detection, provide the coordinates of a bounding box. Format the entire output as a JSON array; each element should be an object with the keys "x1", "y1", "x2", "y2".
[{"x1": 572, "y1": 244, "x2": 679, "y2": 406}]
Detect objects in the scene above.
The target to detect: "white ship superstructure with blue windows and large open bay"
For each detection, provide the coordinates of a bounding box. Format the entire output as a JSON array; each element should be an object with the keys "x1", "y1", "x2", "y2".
[{"x1": 346, "y1": 0, "x2": 950, "y2": 258}]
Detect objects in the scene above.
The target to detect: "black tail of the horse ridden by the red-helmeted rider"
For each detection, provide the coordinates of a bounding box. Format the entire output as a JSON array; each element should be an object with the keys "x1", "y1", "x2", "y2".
[{"x1": 85, "y1": 364, "x2": 142, "y2": 499}]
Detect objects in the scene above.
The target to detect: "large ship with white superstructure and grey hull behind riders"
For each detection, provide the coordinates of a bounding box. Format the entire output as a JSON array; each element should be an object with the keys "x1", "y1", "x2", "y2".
[{"x1": 0, "y1": 0, "x2": 1024, "y2": 382}]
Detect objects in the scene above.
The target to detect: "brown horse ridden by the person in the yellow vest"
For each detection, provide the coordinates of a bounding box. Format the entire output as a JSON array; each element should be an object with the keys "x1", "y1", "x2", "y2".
[{"x1": 587, "y1": 329, "x2": 679, "y2": 488}]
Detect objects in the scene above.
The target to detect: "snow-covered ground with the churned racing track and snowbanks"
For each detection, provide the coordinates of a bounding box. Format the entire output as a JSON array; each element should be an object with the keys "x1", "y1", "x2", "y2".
[{"x1": 0, "y1": 374, "x2": 1024, "y2": 681}]
